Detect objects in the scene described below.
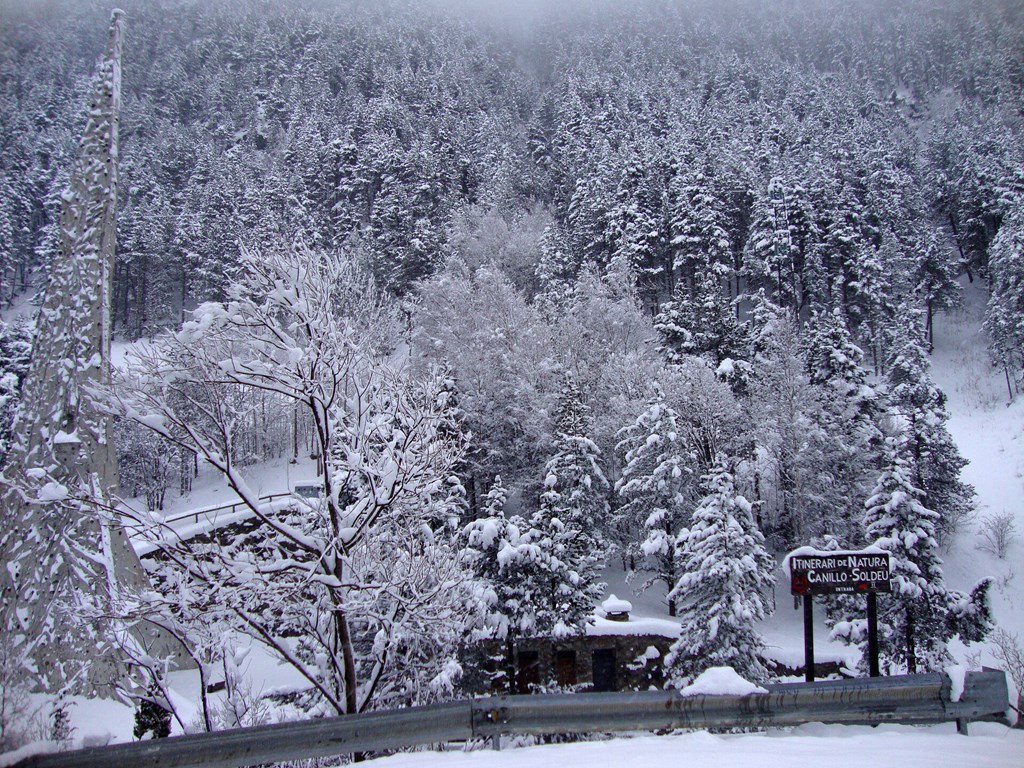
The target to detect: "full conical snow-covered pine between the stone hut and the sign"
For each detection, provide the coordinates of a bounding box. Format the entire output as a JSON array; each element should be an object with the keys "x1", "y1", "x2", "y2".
[{"x1": 666, "y1": 455, "x2": 775, "y2": 687}]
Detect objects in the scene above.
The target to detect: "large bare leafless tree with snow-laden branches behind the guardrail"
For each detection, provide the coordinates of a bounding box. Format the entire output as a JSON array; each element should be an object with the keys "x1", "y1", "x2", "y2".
[{"x1": 97, "y1": 247, "x2": 472, "y2": 714}]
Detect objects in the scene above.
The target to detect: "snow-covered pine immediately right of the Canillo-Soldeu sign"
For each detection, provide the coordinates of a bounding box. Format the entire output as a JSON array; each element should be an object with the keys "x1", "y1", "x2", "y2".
[{"x1": 847, "y1": 417, "x2": 991, "y2": 674}]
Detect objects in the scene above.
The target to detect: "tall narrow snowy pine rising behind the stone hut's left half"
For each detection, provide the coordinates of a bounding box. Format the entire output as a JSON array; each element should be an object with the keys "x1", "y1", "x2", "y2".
[{"x1": 529, "y1": 379, "x2": 609, "y2": 636}]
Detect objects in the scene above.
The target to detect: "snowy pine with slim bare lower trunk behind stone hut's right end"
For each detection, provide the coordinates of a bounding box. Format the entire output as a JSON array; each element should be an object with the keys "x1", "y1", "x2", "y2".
[{"x1": 615, "y1": 387, "x2": 696, "y2": 616}]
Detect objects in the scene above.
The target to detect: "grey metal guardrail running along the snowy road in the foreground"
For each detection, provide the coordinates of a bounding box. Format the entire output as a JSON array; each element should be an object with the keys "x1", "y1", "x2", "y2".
[{"x1": 13, "y1": 670, "x2": 1008, "y2": 768}]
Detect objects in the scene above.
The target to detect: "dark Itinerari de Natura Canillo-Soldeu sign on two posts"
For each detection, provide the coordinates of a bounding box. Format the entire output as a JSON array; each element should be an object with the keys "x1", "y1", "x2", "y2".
[{"x1": 782, "y1": 547, "x2": 892, "y2": 683}]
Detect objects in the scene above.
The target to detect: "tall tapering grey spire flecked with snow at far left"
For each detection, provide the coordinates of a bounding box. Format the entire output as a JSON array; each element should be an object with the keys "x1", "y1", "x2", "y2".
[{"x1": 0, "y1": 11, "x2": 189, "y2": 695}]
